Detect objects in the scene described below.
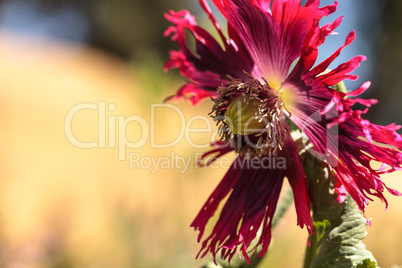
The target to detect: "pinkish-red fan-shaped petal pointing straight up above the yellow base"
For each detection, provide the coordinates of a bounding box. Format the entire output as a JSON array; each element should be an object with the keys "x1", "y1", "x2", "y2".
[{"x1": 214, "y1": 0, "x2": 336, "y2": 81}]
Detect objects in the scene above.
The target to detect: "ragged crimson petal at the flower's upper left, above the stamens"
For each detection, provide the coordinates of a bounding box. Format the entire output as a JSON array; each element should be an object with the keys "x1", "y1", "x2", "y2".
[{"x1": 164, "y1": 7, "x2": 254, "y2": 103}]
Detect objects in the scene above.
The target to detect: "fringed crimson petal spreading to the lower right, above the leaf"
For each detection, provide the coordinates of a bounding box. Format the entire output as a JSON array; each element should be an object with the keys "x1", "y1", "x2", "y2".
[{"x1": 289, "y1": 78, "x2": 402, "y2": 214}]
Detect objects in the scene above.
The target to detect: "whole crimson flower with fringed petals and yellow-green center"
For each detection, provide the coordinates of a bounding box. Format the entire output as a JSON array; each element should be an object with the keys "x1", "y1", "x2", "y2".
[{"x1": 165, "y1": 0, "x2": 402, "y2": 262}]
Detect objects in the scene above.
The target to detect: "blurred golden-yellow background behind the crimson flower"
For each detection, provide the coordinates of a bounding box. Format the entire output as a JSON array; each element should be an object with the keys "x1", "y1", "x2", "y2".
[{"x1": 0, "y1": 0, "x2": 402, "y2": 268}]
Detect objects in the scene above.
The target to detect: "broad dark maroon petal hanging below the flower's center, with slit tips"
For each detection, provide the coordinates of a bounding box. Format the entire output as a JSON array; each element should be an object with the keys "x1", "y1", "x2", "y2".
[{"x1": 191, "y1": 157, "x2": 284, "y2": 260}]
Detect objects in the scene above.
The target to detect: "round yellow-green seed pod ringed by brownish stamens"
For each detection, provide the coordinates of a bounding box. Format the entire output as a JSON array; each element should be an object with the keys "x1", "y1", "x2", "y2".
[{"x1": 210, "y1": 77, "x2": 289, "y2": 158}]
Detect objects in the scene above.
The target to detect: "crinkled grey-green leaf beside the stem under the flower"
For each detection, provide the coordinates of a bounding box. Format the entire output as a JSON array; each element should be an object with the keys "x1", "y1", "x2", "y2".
[{"x1": 302, "y1": 152, "x2": 377, "y2": 268}]
